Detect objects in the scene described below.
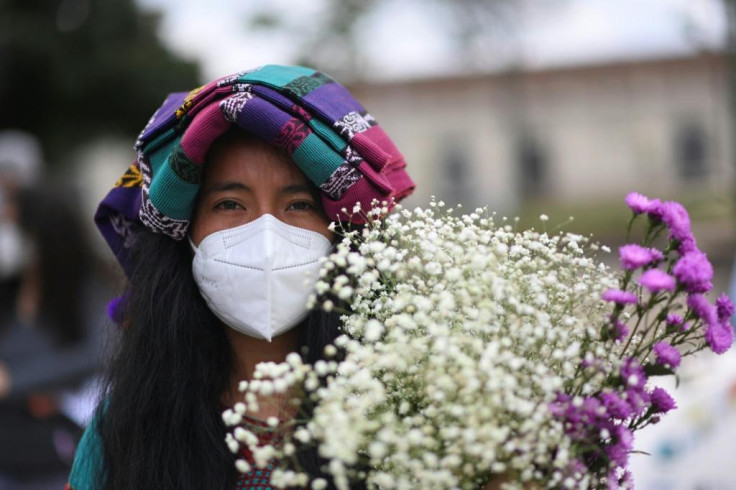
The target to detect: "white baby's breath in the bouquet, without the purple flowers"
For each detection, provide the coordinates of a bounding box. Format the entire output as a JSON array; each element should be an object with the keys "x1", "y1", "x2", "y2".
[{"x1": 223, "y1": 201, "x2": 620, "y2": 490}]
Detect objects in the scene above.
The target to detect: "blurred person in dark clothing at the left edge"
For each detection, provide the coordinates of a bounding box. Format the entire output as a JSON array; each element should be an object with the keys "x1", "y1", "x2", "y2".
[{"x1": 0, "y1": 132, "x2": 104, "y2": 490}]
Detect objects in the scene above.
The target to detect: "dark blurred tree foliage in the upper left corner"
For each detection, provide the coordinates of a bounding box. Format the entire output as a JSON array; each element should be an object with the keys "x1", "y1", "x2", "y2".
[{"x1": 0, "y1": 0, "x2": 198, "y2": 165}]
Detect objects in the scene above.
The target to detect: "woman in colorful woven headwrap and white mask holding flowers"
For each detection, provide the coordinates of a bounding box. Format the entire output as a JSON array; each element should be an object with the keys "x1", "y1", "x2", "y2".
[{"x1": 68, "y1": 65, "x2": 413, "y2": 490}]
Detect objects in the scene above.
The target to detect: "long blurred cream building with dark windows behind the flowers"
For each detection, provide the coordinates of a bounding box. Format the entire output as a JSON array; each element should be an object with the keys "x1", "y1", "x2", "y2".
[{"x1": 352, "y1": 52, "x2": 733, "y2": 213}]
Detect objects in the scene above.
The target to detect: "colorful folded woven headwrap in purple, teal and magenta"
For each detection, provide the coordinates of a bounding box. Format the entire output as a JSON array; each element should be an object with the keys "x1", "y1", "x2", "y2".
[{"x1": 95, "y1": 65, "x2": 414, "y2": 269}]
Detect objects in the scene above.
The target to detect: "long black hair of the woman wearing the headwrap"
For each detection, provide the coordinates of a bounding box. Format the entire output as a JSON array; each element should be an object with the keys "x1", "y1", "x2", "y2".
[{"x1": 95, "y1": 231, "x2": 339, "y2": 490}]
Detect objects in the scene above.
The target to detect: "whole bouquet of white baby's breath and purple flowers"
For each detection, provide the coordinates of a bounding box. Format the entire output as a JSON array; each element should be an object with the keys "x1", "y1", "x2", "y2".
[{"x1": 223, "y1": 193, "x2": 734, "y2": 489}]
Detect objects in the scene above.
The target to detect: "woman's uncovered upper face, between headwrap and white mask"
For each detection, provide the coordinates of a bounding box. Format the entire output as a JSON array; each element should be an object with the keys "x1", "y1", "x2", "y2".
[{"x1": 191, "y1": 137, "x2": 334, "y2": 246}]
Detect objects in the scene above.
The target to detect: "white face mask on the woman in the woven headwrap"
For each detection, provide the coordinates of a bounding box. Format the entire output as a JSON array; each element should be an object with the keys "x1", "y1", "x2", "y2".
[{"x1": 190, "y1": 214, "x2": 332, "y2": 342}]
